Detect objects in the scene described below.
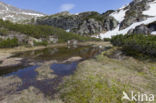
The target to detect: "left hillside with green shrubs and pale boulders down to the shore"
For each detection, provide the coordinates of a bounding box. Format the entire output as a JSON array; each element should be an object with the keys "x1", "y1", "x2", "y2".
[{"x1": 0, "y1": 20, "x2": 98, "y2": 48}]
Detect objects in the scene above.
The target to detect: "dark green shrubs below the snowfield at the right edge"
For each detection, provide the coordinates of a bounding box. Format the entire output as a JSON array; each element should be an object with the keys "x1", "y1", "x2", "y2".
[{"x1": 111, "y1": 34, "x2": 156, "y2": 57}]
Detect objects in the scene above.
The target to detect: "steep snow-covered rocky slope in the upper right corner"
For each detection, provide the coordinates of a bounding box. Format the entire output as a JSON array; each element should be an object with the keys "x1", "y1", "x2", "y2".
[{"x1": 100, "y1": 0, "x2": 156, "y2": 39}]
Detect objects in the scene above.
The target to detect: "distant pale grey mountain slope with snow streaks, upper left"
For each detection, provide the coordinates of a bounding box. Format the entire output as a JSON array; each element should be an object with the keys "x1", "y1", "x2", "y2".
[{"x1": 0, "y1": 2, "x2": 45, "y2": 22}]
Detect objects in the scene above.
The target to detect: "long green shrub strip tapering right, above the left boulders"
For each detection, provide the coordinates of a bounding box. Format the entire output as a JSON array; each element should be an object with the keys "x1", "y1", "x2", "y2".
[{"x1": 0, "y1": 20, "x2": 99, "y2": 42}]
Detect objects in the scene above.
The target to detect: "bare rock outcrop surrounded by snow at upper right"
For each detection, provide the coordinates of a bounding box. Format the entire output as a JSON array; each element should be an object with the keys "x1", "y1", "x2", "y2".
[{"x1": 120, "y1": 0, "x2": 153, "y2": 30}]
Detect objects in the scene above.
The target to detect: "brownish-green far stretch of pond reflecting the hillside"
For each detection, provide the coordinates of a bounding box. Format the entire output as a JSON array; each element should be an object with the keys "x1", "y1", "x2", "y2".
[{"x1": 12, "y1": 46, "x2": 102, "y2": 61}]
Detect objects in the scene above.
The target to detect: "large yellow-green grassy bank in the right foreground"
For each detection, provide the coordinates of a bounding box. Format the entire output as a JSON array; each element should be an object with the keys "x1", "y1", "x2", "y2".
[{"x1": 55, "y1": 48, "x2": 156, "y2": 103}]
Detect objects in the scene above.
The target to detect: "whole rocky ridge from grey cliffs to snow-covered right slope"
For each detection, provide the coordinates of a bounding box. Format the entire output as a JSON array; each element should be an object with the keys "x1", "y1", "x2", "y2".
[{"x1": 36, "y1": 0, "x2": 156, "y2": 38}]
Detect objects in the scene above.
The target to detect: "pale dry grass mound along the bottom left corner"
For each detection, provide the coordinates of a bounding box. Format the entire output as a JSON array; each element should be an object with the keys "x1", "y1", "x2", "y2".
[{"x1": 1, "y1": 87, "x2": 63, "y2": 103}]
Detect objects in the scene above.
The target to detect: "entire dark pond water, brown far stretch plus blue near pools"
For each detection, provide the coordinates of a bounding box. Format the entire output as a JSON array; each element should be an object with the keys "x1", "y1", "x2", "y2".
[{"x1": 0, "y1": 46, "x2": 103, "y2": 96}]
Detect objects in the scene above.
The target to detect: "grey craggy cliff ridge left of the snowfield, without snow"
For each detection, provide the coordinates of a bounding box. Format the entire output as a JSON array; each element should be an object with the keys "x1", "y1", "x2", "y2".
[{"x1": 36, "y1": 11, "x2": 118, "y2": 35}]
